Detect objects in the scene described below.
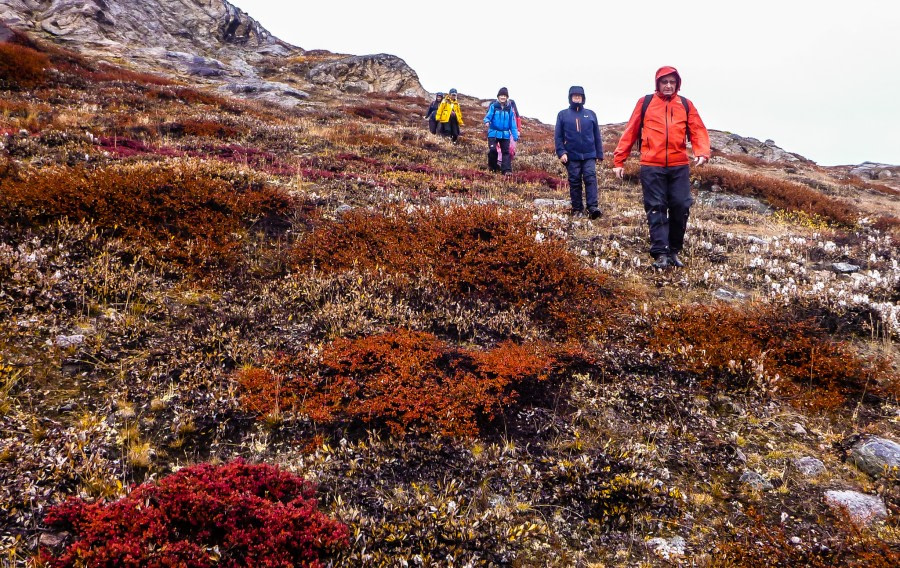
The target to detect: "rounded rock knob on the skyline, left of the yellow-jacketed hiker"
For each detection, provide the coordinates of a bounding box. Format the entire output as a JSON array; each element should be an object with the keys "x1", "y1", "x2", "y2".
[{"x1": 306, "y1": 53, "x2": 428, "y2": 97}]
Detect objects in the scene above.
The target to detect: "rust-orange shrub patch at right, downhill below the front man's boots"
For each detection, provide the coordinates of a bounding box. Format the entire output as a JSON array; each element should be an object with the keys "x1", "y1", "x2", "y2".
[{"x1": 653, "y1": 305, "x2": 886, "y2": 410}]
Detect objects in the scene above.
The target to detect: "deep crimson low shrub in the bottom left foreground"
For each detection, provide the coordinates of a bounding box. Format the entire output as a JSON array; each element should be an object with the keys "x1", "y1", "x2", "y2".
[{"x1": 44, "y1": 460, "x2": 348, "y2": 568}]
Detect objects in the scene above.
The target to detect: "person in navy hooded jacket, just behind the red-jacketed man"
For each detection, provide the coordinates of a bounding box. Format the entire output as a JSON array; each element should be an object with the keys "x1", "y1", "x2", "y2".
[{"x1": 556, "y1": 87, "x2": 603, "y2": 219}]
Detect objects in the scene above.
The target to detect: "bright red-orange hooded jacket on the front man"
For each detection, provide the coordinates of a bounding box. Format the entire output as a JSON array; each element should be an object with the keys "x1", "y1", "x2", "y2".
[{"x1": 613, "y1": 66, "x2": 709, "y2": 168}]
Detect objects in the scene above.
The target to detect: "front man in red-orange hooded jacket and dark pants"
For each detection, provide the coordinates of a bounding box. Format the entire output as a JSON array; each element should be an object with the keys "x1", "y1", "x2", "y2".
[{"x1": 613, "y1": 66, "x2": 709, "y2": 269}]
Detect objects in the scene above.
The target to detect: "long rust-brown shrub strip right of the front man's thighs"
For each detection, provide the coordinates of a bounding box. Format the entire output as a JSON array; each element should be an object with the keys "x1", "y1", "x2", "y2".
[{"x1": 692, "y1": 166, "x2": 859, "y2": 226}]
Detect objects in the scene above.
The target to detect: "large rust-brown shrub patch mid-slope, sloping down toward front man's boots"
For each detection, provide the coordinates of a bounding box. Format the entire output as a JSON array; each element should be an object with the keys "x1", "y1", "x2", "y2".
[{"x1": 294, "y1": 206, "x2": 623, "y2": 335}]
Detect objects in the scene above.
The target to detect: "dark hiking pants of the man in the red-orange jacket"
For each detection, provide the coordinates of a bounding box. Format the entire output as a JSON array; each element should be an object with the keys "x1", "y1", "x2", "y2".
[{"x1": 641, "y1": 166, "x2": 694, "y2": 258}]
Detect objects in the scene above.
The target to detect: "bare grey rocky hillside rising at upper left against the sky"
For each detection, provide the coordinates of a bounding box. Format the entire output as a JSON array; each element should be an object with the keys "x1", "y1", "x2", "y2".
[{"x1": 0, "y1": 0, "x2": 428, "y2": 106}]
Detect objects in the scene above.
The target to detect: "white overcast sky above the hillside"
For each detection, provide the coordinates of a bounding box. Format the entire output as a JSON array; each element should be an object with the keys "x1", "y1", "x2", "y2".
[{"x1": 229, "y1": 0, "x2": 900, "y2": 165}]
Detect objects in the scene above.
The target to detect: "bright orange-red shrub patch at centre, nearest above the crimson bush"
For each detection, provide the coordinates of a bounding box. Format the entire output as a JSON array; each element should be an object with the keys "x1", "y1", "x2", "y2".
[{"x1": 237, "y1": 330, "x2": 572, "y2": 436}]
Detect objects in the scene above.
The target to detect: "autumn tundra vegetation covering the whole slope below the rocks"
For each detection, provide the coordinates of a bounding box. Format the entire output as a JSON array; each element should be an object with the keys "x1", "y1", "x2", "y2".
[{"x1": 0, "y1": 32, "x2": 900, "y2": 567}]
